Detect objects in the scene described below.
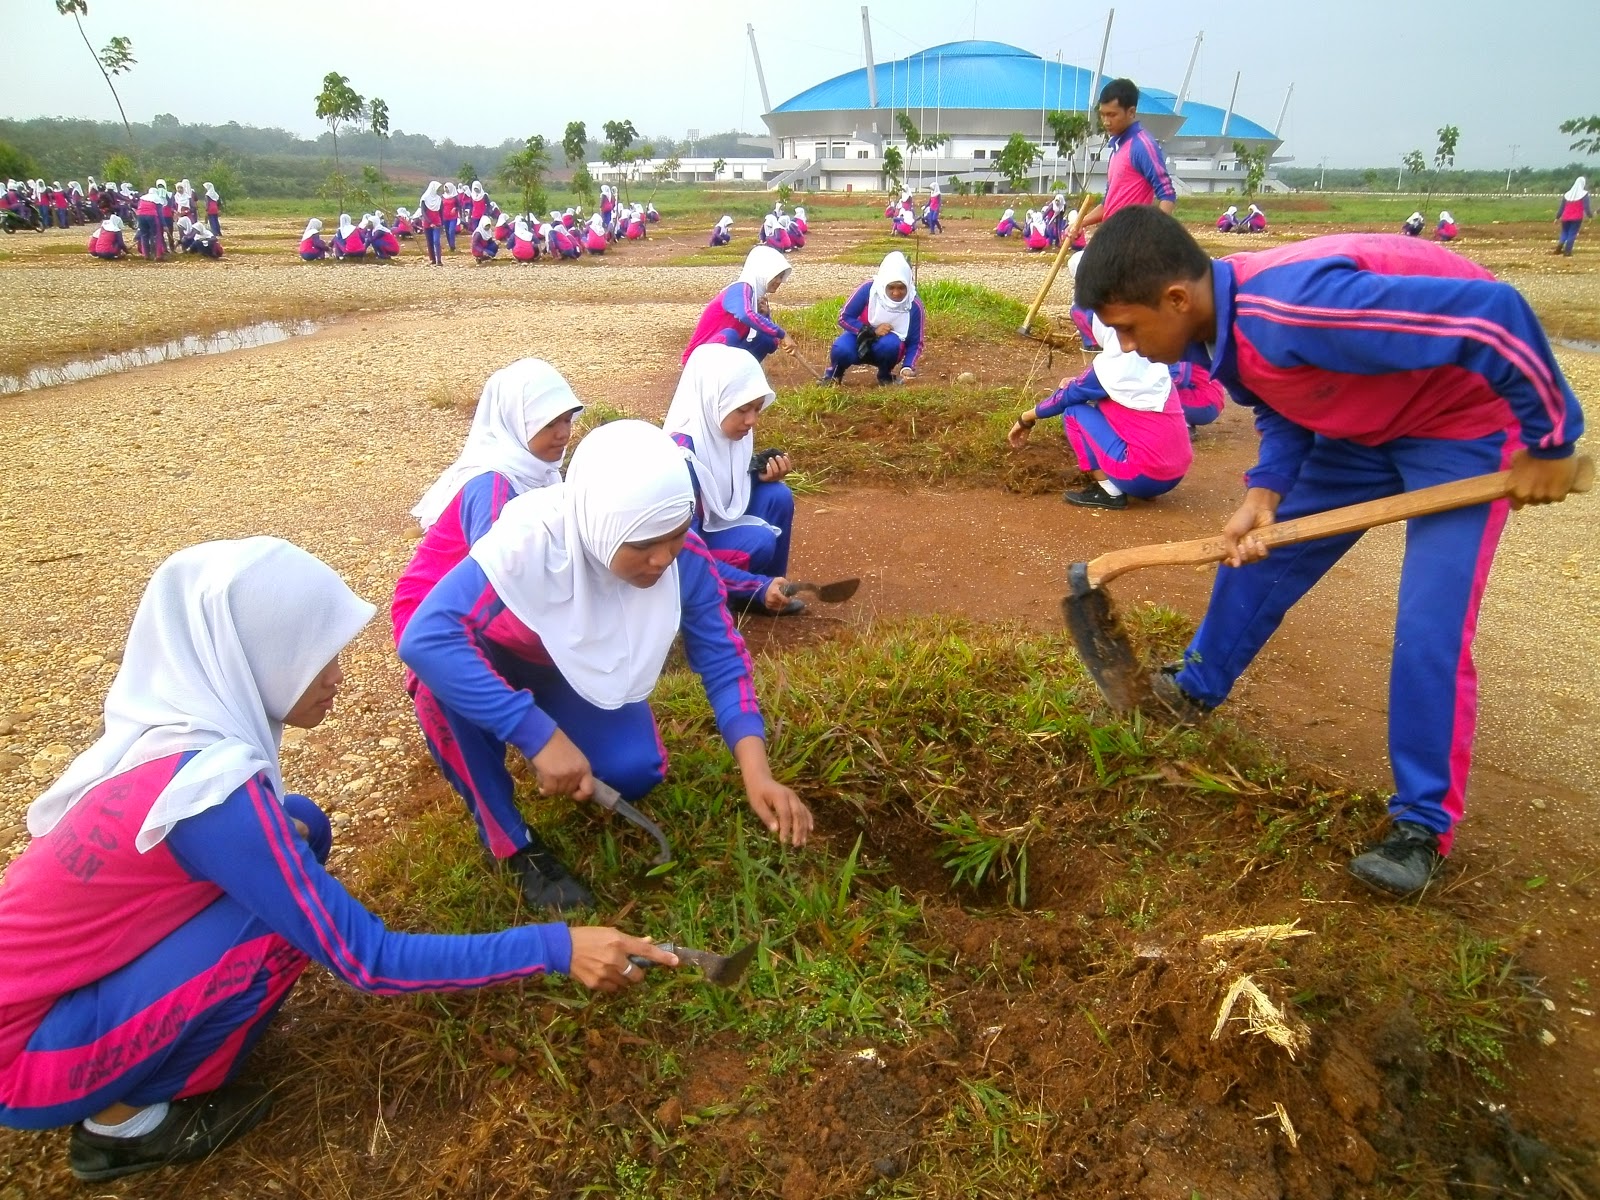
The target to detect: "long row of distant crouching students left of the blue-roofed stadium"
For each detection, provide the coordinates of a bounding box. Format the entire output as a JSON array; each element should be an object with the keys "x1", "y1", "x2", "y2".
[{"x1": 299, "y1": 179, "x2": 661, "y2": 266}]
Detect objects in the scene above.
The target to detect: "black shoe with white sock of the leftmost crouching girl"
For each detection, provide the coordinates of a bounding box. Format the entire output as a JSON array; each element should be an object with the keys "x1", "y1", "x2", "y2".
[{"x1": 67, "y1": 1083, "x2": 272, "y2": 1182}]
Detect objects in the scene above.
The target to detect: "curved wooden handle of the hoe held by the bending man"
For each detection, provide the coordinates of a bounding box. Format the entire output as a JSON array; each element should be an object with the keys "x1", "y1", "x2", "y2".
[{"x1": 1088, "y1": 454, "x2": 1595, "y2": 587}]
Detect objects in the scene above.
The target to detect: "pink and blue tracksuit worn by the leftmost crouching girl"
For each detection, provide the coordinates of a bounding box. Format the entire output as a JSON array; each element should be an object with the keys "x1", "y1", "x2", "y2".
[{"x1": 0, "y1": 752, "x2": 571, "y2": 1130}]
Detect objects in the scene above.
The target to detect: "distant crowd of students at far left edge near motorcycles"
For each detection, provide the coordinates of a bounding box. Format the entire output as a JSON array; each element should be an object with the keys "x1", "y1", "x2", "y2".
[{"x1": 0, "y1": 176, "x2": 222, "y2": 261}]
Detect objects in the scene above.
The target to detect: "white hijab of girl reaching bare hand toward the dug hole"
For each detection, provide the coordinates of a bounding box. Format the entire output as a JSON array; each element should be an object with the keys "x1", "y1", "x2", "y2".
[{"x1": 472, "y1": 421, "x2": 694, "y2": 709}]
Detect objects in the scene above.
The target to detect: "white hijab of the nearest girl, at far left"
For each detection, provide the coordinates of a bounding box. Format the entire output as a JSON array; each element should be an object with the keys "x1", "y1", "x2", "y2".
[{"x1": 27, "y1": 538, "x2": 376, "y2": 853}]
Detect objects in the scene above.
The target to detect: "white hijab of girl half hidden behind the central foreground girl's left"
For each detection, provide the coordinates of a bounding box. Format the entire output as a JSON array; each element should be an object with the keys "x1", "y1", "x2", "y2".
[{"x1": 411, "y1": 361, "x2": 585, "y2": 530}]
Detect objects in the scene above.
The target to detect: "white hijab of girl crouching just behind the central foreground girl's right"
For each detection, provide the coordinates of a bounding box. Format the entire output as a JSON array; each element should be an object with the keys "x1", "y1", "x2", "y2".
[{"x1": 661, "y1": 342, "x2": 776, "y2": 533}]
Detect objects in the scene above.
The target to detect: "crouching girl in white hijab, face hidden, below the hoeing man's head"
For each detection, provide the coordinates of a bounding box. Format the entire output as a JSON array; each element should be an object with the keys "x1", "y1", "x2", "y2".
[{"x1": 1006, "y1": 321, "x2": 1194, "y2": 509}]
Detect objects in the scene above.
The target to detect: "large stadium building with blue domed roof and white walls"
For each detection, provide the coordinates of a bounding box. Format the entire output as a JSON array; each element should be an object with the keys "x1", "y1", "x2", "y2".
[{"x1": 748, "y1": 42, "x2": 1288, "y2": 192}]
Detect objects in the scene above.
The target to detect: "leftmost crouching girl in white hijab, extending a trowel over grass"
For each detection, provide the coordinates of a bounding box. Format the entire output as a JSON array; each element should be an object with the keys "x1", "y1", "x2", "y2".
[{"x1": 0, "y1": 534, "x2": 668, "y2": 1181}]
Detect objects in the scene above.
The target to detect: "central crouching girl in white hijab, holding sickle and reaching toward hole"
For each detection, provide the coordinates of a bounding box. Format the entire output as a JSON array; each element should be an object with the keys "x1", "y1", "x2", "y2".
[{"x1": 400, "y1": 421, "x2": 811, "y2": 909}]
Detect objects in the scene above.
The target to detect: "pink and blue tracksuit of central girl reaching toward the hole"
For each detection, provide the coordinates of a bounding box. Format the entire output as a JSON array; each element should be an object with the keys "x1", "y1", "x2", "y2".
[{"x1": 400, "y1": 533, "x2": 766, "y2": 859}]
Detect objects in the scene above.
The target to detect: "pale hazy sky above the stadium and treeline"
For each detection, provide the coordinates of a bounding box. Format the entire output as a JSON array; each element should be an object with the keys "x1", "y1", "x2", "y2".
[{"x1": 0, "y1": 0, "x2": 1600, "y2": 168}]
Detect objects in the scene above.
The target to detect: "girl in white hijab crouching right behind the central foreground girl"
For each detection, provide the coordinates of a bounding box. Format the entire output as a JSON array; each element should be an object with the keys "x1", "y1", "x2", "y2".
[{"x1": 662, "y1": 342, "x2": 805, "y2": 616}]
